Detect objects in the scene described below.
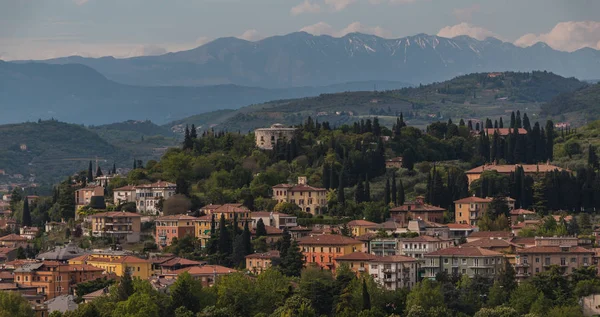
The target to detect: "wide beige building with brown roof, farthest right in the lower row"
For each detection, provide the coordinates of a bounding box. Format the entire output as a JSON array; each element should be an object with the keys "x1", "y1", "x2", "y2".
[{"x1": 515, "y1": 245, "x2": 595, "y2": 281}]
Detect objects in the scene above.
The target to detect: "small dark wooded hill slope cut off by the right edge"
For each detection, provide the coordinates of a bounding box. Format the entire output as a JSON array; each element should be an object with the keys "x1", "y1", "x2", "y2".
[{"x1": 542, "y1": 84, "x2": 600, "y2": 120}]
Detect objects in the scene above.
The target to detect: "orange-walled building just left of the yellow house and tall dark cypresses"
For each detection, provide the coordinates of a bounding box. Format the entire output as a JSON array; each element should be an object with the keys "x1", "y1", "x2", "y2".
[{"x1": 155, "y1": 215, "x2": 196, "y2": 249}]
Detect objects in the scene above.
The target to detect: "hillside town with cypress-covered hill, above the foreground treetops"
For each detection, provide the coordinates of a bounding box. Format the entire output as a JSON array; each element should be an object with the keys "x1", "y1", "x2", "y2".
[{"x1": 0, "y1": 113, "x2": 600, "y2": 316}]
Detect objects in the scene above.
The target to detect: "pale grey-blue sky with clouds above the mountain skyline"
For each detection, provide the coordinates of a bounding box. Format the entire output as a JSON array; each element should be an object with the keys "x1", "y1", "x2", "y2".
[{"x1": 0, "y1": 0, "x2": 600, "y2": 60}]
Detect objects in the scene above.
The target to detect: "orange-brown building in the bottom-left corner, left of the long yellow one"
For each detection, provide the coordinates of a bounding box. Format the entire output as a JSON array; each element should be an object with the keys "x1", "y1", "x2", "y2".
[{"x1": 14, "y1": 261, "x2": 104, "y2": 300}]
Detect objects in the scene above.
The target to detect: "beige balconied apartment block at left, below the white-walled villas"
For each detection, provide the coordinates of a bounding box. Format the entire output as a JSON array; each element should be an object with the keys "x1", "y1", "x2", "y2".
[{"x1": 90, "y1": 211, "x2": 142, "y2": 243}]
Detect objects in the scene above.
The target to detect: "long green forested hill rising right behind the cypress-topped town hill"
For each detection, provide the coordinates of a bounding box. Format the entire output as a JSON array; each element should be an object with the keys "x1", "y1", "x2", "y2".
[{"x1": 170, "y1": 71, "x2": 585, "y2": 132}]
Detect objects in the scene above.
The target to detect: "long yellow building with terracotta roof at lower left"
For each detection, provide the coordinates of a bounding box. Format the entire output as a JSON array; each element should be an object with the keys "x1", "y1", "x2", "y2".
[{"x1": 69, "y1": 252, "x2": 152, "y2": 280}]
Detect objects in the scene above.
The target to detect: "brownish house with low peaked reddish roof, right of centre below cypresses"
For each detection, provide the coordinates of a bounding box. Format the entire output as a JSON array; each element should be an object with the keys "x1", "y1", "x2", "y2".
[{"x1": 390, "y1": 196, "x2": 446, "y2": 226}]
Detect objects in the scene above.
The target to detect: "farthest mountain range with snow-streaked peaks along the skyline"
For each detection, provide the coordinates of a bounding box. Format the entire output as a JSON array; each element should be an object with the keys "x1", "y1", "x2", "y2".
[{"x1": 25, "y1": 32, "x2": 600, "y2": 88}]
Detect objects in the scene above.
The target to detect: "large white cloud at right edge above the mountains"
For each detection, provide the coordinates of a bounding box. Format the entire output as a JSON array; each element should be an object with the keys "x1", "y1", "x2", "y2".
[{"x1": 515, "y1": 21, "x2": 600, "y2": 52}]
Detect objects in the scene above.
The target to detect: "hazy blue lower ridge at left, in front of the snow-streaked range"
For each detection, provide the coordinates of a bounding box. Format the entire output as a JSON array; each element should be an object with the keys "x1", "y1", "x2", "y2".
[{"x1": 0, "y1": 61, "x2": 407, "y2": 125}]
